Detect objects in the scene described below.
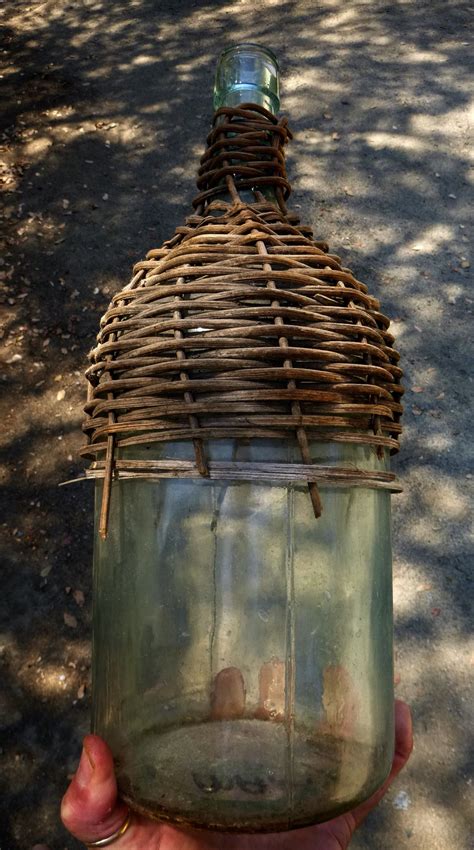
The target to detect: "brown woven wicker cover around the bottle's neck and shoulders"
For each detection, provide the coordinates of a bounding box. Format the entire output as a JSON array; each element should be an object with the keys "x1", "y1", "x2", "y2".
[{"x1": 82, "y1": 104, "x2": 403, "y2": 534}]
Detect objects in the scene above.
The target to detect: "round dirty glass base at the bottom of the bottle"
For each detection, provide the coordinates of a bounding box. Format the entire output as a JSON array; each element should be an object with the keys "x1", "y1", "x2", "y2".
[{"x1": 117, "y1": 719, "x2": 385, "y2": 833}]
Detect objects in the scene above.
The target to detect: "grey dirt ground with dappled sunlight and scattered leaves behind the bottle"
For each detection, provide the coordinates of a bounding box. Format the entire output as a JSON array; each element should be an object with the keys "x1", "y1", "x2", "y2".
[{"x1": 0, "y1": 0, "x2": 474, "y2": 850}]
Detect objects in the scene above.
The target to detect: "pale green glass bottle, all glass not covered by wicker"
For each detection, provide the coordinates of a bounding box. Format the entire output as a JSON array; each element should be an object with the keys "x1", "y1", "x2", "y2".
[{"x1": 93, "y1": 45, "x2": 394, "y2": 832}]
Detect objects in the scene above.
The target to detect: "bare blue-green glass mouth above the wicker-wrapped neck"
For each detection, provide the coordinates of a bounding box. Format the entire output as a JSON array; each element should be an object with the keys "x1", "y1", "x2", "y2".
[{"x1": 214, "y1": 42, "x2": 280, "y2": 114}]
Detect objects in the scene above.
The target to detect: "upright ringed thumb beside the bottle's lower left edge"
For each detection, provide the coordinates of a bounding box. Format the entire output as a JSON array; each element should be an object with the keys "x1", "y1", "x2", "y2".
[{"x1": 61, "y1": 735, "x2": 128, "y2": 843}]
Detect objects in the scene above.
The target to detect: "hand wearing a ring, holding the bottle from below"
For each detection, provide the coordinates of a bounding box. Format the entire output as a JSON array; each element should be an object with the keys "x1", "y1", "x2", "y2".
[{"x1": 61, "y1": 700, "x2": 413, "y2": 850}]
